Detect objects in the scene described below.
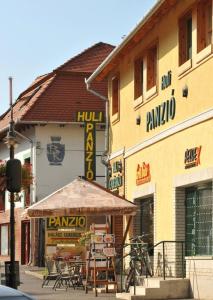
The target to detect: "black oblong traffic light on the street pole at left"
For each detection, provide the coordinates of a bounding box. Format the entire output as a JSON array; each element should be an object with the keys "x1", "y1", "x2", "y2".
[{"x1": 6, "y1": 159, "x2": 21, "y2": 193}]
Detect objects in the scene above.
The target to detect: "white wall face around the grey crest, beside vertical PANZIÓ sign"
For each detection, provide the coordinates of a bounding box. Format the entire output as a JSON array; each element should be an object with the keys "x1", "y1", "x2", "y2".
[{"x1": 36, "y1": 124, "x2": 104, "y2": 201}]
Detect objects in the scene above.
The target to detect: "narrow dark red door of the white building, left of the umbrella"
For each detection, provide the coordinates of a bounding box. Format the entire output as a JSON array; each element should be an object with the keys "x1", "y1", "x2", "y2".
[{"x1": 21, "y1": 221, "x2": 30, "y2": 265}]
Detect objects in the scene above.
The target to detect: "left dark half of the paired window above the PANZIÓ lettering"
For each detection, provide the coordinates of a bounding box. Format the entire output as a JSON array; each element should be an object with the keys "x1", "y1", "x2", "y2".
[{"x1": 134, "y1": 58, "x2": 143, "y2": 100}]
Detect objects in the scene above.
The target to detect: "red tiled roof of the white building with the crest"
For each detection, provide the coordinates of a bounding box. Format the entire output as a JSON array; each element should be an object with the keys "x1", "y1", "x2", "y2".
[{"x1": 0, "y1": 43, "x2": 114, "y2": 131}]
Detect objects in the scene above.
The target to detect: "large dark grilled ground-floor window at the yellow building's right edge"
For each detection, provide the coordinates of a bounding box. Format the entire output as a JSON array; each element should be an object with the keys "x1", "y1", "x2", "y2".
[{"x1": 185, "y1": 185, "x2": 213, "y2": 256}]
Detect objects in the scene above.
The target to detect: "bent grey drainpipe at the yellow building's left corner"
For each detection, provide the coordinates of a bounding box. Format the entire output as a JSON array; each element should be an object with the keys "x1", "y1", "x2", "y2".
[{"x1": 85, "y1": 78, "x2": 109, "y2": 188}]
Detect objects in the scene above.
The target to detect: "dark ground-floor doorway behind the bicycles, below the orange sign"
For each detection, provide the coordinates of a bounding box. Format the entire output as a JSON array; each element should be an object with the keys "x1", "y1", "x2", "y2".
[{"x1": 133, "y1": 197, "x2": 154, "y2": 246}]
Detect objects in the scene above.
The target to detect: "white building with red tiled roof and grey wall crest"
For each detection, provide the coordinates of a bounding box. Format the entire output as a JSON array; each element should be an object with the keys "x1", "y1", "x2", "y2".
[{"x1": 0, "y1": 43, "x2": 113, "y2": 264}]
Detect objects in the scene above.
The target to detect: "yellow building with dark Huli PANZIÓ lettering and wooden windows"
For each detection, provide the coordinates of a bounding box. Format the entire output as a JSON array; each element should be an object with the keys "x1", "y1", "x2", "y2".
[{"x1": 87, "y1": 0, "x2": 213, "y2": 299}]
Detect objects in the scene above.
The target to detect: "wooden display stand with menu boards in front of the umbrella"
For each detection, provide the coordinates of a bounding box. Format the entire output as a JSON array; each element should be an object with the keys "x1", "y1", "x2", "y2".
[{"x1": 85, "y1": 223, "x2": 117, "y2": 296}]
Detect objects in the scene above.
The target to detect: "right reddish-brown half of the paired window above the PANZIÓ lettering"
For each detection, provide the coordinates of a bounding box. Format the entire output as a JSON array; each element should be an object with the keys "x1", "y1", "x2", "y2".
[{"x1": 147, "y1": 46, "x2": 157, "y2": 90}]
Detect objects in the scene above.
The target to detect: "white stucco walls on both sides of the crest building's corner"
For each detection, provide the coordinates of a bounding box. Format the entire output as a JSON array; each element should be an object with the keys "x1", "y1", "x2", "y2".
[{"x1": 0, "y1": 124, "x2": 105, "y2": 210}]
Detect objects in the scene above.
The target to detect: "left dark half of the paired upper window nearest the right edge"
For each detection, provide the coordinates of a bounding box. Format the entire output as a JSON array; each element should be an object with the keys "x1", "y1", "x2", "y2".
[{"x1": 179, "y1": 12, "x2": 192, "y2": 65}]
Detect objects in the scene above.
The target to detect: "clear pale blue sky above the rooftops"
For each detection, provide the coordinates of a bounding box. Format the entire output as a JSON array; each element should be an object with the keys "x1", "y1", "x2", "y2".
[{"x1": 0, "y1": 0, "x2": 156, "y2": 115}]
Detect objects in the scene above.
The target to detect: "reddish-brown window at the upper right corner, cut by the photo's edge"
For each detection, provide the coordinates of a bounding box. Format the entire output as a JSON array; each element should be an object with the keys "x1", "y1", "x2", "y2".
[{"x1": 197, "y1": 0, "x2": 212, "y2": 52}]
